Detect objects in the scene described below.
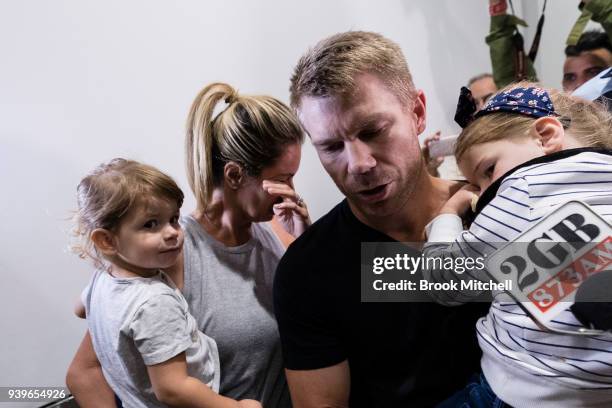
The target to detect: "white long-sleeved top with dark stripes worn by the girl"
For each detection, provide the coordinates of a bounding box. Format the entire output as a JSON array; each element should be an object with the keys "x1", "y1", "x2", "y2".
[{"x1": 424, "y1": 152, "x2": 612, "y2": 407}]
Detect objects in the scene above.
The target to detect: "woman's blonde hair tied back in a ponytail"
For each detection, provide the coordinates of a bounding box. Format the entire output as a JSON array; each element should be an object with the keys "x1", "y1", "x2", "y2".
[{"x1": 185, "y1": 83, "x2": 304, "y2": 208}]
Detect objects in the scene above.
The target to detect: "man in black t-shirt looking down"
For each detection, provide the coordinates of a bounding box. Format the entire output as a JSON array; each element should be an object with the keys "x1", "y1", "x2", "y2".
[{"x1": 274, "y1": 31, "x2": 487, "y2": 408}]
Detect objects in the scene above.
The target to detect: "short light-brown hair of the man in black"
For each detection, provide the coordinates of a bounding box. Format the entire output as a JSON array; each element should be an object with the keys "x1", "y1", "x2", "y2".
[{"x1": 289, "y1": 31, "x2": 416, "y2": 109}]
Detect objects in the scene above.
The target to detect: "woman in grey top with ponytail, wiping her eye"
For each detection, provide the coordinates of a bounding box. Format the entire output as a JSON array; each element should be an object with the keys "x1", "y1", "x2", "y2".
[{"x1": 67, "y1": 83, "x2": 310, "y2": 407}]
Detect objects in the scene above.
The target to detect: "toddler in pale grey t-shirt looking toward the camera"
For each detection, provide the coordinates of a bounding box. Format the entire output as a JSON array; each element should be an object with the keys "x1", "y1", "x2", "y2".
[{"x1": 76, "y1": 159, "x2": 261, "y2": 408}]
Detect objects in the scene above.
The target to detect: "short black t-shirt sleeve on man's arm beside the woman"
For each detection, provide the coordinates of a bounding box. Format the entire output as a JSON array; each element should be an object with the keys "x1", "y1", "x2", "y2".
[{"x1": 274, "y1": 242, "x2": 347, "y2": 370}]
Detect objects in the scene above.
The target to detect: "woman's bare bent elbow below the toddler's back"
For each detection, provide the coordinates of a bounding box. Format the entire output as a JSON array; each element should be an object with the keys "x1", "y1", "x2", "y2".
[{"x1": 66, "y1": 331, "x2": 117, "y2": 408}]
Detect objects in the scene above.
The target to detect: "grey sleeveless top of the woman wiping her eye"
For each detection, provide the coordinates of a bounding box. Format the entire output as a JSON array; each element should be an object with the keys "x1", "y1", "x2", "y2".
[{"x1": 181, "y1": 216, "x2": 291, "y2": 408}]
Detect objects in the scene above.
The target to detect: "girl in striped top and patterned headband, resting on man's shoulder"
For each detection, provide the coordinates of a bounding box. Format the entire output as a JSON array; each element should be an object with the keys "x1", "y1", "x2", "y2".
[{"x1": 423, "y1": 83, "x2": 612, "y2": 407}]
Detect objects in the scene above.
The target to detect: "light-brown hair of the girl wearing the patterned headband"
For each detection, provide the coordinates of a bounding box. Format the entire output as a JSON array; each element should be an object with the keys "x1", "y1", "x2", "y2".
[{"x1": 455, "y1": 82, "x2": 612, "y2": 161}]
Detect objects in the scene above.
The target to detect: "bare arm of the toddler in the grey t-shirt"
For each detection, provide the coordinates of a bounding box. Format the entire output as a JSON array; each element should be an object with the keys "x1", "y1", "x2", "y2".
[{"x1": 147, "y1": 353, "x2": 261, "y2": 408}]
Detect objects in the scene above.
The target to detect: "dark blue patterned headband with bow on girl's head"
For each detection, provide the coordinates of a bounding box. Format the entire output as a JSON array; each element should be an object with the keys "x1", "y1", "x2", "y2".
[{"x1": 455, "y1": 83, "x2": 558, "y2": 128}]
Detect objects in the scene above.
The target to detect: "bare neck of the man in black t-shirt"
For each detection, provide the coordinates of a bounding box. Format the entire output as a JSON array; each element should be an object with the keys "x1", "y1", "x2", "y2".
[{"x1": 348, "y1": 175, "x2": 462, "y2": 242}]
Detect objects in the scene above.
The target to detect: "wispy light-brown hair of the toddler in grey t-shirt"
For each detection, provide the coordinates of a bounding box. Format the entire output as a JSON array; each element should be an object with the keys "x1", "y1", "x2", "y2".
[{"x1": 72, "y1": 158, "x2": 183, "y2": 267}]
